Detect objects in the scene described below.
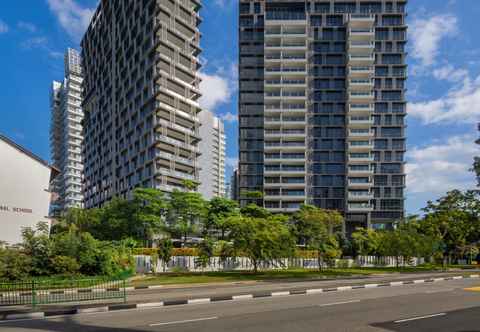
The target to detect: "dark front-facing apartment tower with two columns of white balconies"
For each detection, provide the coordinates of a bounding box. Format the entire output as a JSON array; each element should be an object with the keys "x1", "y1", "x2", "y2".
[{"x1": 239, "y1": 0, "x2": 407, "y2": 233}]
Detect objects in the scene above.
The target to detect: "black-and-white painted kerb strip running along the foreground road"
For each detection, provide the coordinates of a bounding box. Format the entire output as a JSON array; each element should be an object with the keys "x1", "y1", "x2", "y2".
[{"x1": 0, "y1": 274, "x2": 480, "y2": 323}]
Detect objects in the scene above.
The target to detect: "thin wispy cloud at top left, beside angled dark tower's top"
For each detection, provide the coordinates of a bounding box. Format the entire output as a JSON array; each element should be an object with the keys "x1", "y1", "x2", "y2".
[{"x1": 47, "y1": 0, "x2": 95, "y2": 42}]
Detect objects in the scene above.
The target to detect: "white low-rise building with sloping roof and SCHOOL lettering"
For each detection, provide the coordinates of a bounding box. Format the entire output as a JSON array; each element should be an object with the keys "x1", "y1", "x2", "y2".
[{"x1": 0, "y1": 135, "x2": 58, "y2": 244}]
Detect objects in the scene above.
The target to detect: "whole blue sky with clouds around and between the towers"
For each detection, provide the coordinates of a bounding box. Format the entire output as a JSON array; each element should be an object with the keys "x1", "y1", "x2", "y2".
[{"x1": 0, "y1": 0, "x2": 480, "y2": 213}]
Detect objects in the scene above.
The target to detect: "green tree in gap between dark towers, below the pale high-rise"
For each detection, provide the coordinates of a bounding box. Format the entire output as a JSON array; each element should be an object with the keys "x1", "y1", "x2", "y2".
[{"x1": 204, "y1": 197, "x2": 239, "y2": 240}]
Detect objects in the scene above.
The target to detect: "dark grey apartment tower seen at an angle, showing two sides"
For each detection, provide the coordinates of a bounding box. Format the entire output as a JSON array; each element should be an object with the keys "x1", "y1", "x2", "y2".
[{"x1": 82, "y1": 0, "x2": 201, "y2": 208}]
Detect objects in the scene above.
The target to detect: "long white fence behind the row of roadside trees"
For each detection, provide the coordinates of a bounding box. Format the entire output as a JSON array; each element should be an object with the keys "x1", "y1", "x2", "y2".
[{"x1": 135, "y1": 255, "x2": 423, "y2": 273}]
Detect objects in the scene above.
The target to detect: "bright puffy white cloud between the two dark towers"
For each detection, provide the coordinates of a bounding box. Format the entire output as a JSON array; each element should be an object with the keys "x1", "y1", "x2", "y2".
[{"x1": 199, "y1": 64, "x2": 237, "y2": 111}]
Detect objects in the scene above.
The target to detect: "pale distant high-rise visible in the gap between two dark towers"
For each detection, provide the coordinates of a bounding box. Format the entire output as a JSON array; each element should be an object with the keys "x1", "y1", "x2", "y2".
[{"x1": 198, "y1": 110, "x2": 225, "y2": 199}]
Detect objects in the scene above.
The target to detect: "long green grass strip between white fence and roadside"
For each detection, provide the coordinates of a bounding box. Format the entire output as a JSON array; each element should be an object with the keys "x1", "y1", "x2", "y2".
[{"x1": 129, "y1": 266, "x2": 454, "y2": 286}]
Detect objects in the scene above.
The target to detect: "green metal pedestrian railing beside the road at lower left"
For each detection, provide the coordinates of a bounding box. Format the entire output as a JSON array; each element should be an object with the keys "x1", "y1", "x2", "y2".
[{"x1": 0, "y1": 278, "x2": 127, "y2": 306}]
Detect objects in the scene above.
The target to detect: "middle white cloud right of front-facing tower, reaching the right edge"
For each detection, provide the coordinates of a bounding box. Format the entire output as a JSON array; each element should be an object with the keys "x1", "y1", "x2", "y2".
[{"x1": 408, "y1": 72, "x2": 480, "y2": 124}]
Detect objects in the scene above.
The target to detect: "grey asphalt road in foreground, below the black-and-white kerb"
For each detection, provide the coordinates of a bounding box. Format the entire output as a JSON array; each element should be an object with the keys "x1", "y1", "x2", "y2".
[{"x1": 0, "y1": 279, "x2": 480, "y2": 332}]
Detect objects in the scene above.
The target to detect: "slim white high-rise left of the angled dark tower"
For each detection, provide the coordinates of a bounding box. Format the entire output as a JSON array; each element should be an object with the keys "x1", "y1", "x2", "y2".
[{"x1": 50, "y1": 48, "x2": 83, "y2": 215}]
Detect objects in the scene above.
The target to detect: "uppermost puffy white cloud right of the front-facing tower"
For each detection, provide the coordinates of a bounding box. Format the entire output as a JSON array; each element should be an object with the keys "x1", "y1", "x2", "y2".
[{"x1": 409, "y1": 14, "x2": 458, "y2": 66}]
